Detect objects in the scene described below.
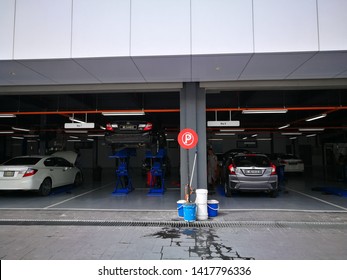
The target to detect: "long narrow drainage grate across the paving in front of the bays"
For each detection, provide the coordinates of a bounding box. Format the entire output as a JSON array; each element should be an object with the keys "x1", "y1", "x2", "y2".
[{"x1": 0, "y1": 219, "x2": 347, "y2": 228}]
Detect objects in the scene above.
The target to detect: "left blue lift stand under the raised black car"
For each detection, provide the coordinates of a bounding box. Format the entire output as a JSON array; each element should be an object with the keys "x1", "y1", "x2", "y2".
[{"x1": 110, "y1": 148, "x2": 136, "y2": 195}]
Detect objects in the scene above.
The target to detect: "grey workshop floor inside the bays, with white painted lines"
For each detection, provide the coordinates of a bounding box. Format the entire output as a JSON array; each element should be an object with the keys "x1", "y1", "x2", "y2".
[{"x1": 0, "y1": 167, "x2": 347, "y2": 211}]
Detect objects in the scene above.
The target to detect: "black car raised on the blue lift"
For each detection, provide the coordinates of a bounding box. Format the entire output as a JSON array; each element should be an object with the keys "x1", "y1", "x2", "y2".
[{"x1": 105, "y1": 118, "x2": 166, "y2": 149}]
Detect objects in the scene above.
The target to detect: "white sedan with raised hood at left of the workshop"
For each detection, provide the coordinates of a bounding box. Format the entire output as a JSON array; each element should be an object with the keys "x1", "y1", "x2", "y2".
[{"x1": 0, "y1": 151, "x2": 83, "y2": 196}]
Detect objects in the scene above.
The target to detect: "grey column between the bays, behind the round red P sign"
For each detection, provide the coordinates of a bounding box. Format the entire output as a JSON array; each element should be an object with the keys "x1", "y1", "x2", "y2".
[{"x1": 180, "y1": 83, "x2": 207, "y2": 199}]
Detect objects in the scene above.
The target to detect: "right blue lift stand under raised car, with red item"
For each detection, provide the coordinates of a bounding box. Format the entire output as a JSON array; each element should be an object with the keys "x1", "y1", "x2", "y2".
[{"x1": 146, "y1": 149, "x2": 165, "y2": 195}]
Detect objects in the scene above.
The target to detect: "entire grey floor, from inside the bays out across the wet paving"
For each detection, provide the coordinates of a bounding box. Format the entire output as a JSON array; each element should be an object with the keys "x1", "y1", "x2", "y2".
[{"x1": 0, "y1": 167, "x2": 347, "y2": 260}]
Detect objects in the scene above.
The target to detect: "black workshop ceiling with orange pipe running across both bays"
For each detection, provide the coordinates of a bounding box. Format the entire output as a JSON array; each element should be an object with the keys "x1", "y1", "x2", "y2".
[{"x1": 0, "y1": 89, "x2": 347, "y2": 141}]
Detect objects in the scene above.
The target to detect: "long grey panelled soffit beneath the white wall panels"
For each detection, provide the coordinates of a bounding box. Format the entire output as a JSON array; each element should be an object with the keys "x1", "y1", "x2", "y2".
[{"x1": 0, "y1": 51, "x2": 347, "y2": 86}]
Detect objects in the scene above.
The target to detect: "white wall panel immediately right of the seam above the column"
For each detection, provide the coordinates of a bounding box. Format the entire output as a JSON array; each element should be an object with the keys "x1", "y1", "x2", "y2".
[{"x1": 192, "y1": 0, "x2": 253, "y2": 54}]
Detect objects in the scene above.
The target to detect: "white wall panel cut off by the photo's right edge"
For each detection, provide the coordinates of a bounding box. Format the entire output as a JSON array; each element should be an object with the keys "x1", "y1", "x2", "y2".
[{"x1": 318, "y1": 0, "x2": 347, "y2": 51}]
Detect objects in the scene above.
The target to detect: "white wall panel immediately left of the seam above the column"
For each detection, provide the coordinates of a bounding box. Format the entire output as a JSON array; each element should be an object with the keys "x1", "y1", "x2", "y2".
[{"x1": 131, "y1": 0, "x2": 190, "y2": 56}]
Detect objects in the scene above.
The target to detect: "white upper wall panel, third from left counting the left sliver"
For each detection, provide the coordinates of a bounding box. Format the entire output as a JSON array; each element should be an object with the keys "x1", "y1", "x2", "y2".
[{"x1": 72, "y1": 0, "x2": 130, "y2": 57}]
